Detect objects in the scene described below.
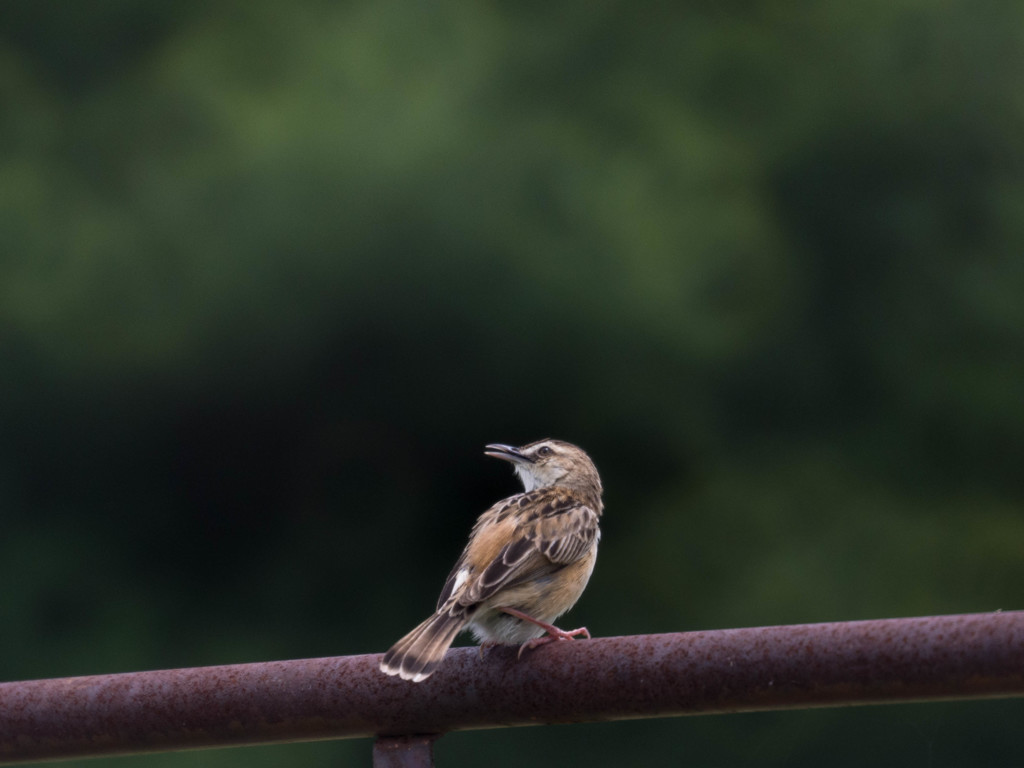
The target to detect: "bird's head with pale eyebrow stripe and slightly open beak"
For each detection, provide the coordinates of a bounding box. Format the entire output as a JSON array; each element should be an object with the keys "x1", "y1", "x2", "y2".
[{"x1": 483, "y1": 439, "x2": 602, "y2": 498}]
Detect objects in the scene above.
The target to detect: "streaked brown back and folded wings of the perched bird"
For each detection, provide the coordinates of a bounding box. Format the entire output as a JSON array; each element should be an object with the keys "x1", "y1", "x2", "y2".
[{"x1": 438, "y1": 488, "x2": 600, "y2": 607}]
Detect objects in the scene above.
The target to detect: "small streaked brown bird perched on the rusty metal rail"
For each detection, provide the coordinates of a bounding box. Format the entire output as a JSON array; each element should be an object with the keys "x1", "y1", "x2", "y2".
[{"x1": 381, "y1": 439, "x2": 603, "y2": 683}]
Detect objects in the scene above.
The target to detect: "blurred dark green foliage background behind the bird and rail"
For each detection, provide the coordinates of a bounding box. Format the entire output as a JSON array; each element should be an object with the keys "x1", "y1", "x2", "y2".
[{"x1": 0, "y1": 0, "x2": 1024, "y2": 768}]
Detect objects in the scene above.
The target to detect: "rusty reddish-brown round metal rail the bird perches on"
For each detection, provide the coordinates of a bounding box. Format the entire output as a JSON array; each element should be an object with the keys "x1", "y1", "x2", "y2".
[{"x1": 0, "y1": 611, "x2": 1024, "y2": 763}]
